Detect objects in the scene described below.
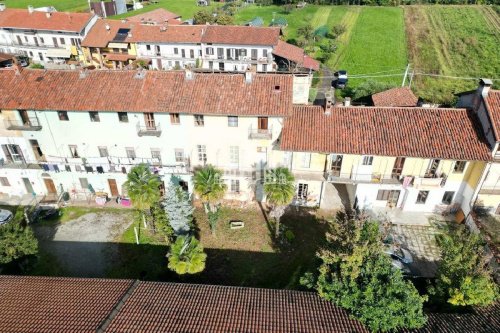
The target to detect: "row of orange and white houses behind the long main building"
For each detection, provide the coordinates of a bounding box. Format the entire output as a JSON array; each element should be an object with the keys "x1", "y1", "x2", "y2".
[{"x1": 82, "y1": 20, "x2": 319, "y2": 73}]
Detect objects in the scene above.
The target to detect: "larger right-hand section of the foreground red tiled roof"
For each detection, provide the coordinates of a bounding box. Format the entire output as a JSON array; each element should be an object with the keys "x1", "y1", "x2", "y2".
[{"x1": 106, "y1": 282, "x2": 368, "y2": 333}]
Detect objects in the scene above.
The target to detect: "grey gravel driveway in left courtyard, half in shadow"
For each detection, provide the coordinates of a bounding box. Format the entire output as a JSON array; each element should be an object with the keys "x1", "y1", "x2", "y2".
[{"x1": 33, "y1": 211, "x2": 133, "y2": 277}]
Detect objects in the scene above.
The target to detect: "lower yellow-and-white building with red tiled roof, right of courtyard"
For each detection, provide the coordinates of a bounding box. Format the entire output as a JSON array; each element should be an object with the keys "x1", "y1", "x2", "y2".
[{"x1": 280, "y1": 105, "x2": 491, "y2": 214}]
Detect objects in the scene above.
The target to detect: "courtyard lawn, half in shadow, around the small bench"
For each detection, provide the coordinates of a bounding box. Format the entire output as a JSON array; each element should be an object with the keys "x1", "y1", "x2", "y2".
[{"x1": 108, "y1": 207, "x2": 326, "y2": 288}]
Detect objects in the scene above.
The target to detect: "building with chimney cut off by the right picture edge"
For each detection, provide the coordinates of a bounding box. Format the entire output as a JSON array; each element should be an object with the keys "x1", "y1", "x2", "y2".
[{"x1": 458, "y1": 79, "x2": 500, "y2": 215}]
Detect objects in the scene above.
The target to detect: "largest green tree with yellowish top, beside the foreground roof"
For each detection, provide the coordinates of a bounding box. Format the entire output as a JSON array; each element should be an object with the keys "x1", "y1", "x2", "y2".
[{"x1": 312, "y1": 213, "x2": 426, "y2": 332}]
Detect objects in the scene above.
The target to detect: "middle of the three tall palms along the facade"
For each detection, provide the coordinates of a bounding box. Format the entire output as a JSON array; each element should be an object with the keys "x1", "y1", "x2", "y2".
[{"x1": 194, "y1": 165, "x2": 227, "y2": 213}]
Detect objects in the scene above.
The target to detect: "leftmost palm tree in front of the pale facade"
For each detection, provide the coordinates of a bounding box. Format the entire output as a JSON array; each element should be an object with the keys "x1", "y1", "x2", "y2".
[{"x1": 125, "y1": 164, "x2": 160, "y2": 228}]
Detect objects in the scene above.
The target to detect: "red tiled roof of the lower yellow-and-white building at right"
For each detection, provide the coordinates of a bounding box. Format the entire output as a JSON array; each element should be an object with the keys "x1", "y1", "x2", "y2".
[{"x1": 281, "y1": 106, "x2": 491, "y2": 160}]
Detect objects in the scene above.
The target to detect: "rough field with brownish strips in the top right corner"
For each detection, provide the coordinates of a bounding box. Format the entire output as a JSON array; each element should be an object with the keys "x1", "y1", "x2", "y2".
[{"x1": 405, "y1": 6, "x2": 500, "y2": 103}]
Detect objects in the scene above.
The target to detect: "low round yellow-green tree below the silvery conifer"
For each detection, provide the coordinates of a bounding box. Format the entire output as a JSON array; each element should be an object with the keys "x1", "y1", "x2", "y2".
[{"x1": 167, "y1": 236, "x2": 207, "y2": 274}]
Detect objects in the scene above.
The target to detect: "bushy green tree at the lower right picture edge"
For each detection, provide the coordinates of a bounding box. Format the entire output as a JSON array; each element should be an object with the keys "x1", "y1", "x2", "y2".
[{"x1": 431, "y1": 226, "x2": 498, "y2": 306}]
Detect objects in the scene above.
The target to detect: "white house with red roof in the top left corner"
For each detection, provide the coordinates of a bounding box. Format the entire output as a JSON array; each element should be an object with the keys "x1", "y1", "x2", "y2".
[{"x1": 0, "y1": 4, "x2": 97, "y2": 65}]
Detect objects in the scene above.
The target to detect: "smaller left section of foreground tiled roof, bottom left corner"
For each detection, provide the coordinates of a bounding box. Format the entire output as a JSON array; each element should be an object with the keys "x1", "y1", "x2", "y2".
[{"x1": 0, "y1": 276, "x2": 133, "y2": 333}]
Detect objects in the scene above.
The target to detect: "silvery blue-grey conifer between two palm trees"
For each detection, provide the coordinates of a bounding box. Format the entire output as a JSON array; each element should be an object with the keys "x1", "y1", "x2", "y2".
[{"x1": 162, "y1": 182, "x2": 194, "y2": 235}]
